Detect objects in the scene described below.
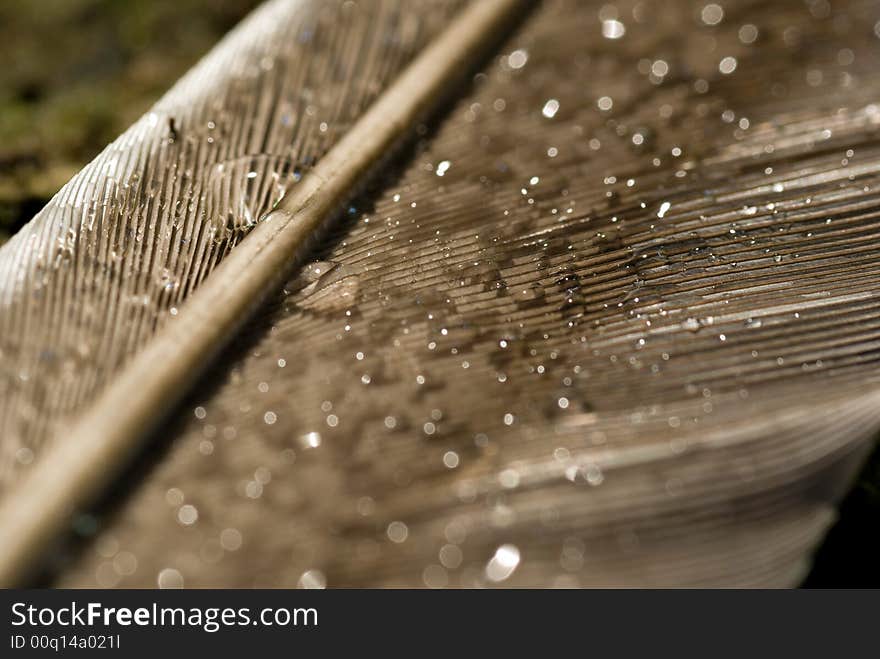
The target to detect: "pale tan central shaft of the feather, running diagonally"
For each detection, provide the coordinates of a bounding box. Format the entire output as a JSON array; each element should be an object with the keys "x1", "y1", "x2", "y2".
[{"x1": 0, "y1": 0, "x2": 525, "y2": 587}]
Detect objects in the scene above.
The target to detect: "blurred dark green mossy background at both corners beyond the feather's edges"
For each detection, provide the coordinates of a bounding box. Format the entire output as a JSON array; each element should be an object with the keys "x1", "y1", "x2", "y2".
[{"x1": 0, "y1": 0, "x2": 880, "y2": 587}]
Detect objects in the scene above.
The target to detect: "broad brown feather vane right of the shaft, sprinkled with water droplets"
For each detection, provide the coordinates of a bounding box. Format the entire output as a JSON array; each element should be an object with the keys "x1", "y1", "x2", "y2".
[{"x1": 4, "y1": 1, "x2": 880, "y2": 587}]
